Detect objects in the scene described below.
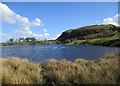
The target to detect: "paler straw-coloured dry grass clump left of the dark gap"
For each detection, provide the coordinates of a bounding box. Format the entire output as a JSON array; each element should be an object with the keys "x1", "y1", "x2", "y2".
[{"x1": 0, "y1": 58, "x2": 42, "y2": 84}]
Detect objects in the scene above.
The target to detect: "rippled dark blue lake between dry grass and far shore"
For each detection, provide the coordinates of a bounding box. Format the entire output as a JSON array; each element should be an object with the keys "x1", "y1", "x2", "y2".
[{"x1": 0, "y1": 44, "x2": 119, "y2": 62}]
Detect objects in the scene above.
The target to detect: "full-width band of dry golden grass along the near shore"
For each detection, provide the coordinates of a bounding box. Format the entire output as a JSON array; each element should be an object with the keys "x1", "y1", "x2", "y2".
[{"x1": 0, "y1": 54, "x2": 120, "y2": 86}]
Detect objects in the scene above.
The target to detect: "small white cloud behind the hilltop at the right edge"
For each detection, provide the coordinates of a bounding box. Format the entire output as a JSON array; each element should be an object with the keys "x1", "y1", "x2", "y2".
[{"x1": 103, "y1": 14, "x2": 120, "y2": 26}]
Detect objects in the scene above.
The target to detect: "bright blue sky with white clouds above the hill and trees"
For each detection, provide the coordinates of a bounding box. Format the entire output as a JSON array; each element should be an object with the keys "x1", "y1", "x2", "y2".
[{"x1": 0, "y1": 2, "x2": 119, "y2": 42}]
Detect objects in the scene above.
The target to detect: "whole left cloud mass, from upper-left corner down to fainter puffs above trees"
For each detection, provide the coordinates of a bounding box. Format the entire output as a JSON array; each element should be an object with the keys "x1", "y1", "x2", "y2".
[{"x1": 0, "y1": 2, "x2": 44, "y2": 37}]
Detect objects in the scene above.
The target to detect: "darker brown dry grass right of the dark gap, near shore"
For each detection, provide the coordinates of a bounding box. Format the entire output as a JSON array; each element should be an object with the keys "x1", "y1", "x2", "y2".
[{"x1": 41, "y1": 55, "x2": 120, "y2": 85}]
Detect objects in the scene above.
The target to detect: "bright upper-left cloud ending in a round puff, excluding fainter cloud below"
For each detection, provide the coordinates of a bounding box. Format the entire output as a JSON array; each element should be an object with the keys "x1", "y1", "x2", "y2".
[{"x1": 0, "y1": 3, "x2": 42, "y2": 26}]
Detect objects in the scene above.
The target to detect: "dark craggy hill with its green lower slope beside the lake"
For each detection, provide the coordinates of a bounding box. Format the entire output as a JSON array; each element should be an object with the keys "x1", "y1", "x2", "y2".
[{"x1": 56, "y1": 24, "x2": 120, "y2": 47}]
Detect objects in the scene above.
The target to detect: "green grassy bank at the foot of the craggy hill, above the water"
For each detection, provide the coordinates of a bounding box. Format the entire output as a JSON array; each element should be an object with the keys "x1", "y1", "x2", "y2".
[{"x1": 66, "y1": 33, "x2": 120, "y2": 47}]
